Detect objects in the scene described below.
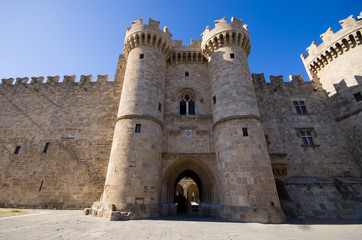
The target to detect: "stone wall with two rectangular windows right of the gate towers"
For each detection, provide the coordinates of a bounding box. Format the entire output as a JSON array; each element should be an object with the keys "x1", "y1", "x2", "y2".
[{"x1": 253, "y1": 74, "x2": 361, "y2": 177}]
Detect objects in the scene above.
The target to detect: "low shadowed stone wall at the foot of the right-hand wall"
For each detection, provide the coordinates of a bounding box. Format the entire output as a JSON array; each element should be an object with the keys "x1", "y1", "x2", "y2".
[{"x1": 277, "y1": 178, "x2": 362, "y2": 219}]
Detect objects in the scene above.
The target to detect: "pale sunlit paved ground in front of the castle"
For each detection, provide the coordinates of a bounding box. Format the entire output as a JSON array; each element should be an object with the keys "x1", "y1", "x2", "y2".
[{"x1": 0, "y1": 210, "x2": 362, "y2": 240}]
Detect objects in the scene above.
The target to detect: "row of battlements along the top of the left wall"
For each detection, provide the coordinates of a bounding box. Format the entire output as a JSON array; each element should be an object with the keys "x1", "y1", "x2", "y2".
[{"x1": 0, "y1": 74, "x2": 110, "y2": 86}]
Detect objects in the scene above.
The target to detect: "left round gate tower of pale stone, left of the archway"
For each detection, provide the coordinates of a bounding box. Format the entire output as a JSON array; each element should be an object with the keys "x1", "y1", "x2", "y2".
[{"x1": 92, "y1": 19, "x2": 171, "y2": 220}]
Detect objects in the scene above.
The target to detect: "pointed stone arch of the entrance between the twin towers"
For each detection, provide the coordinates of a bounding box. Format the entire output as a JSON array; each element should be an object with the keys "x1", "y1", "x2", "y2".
[{"x1": 161, "y1": 158, "x2": 219, "y2": 214}]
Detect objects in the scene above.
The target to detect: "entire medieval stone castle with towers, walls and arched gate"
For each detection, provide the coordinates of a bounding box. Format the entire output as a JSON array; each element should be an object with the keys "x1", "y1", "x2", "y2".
[{"x1": 0, "y1": 13, "x2": 362, "y2": 223}]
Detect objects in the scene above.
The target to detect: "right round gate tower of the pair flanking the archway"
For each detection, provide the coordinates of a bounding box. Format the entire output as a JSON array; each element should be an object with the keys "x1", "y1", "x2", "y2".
[{"x1": 201, "y1": 18, "x2": 284, "y2": 223}]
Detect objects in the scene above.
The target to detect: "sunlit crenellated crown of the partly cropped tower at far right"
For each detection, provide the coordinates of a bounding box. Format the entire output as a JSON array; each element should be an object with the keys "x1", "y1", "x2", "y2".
[{"x1": 301, "y1": 12, "x2": 362, "y2": 78}]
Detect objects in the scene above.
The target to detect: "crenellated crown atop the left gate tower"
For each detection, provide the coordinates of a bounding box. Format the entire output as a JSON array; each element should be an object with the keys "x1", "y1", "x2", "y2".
[{"x1": 124, "y1": 18, "x2": 172, "y2": 59}]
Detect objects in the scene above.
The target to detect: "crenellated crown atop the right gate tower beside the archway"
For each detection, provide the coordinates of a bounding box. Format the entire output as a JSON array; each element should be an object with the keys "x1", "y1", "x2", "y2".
[{"x1": 201, "y1": 17, "x2": 251, "y2": 58}]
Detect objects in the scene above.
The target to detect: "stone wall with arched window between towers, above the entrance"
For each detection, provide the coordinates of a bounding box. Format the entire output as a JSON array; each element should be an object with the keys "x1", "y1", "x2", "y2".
[{"x1": 163, "y1": 64, "x2": 215, "y2": 153}]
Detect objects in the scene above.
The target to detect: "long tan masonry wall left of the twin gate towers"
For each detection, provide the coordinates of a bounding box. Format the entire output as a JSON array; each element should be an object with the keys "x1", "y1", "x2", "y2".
[{"x1": 0, "y1": 73, "x2": 122, "y2": 209}]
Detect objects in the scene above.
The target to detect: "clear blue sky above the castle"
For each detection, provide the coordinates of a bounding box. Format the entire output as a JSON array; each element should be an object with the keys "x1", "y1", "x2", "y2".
[{"x1": 0, "y1": 0, "x2": 362, "y2": 81}]
